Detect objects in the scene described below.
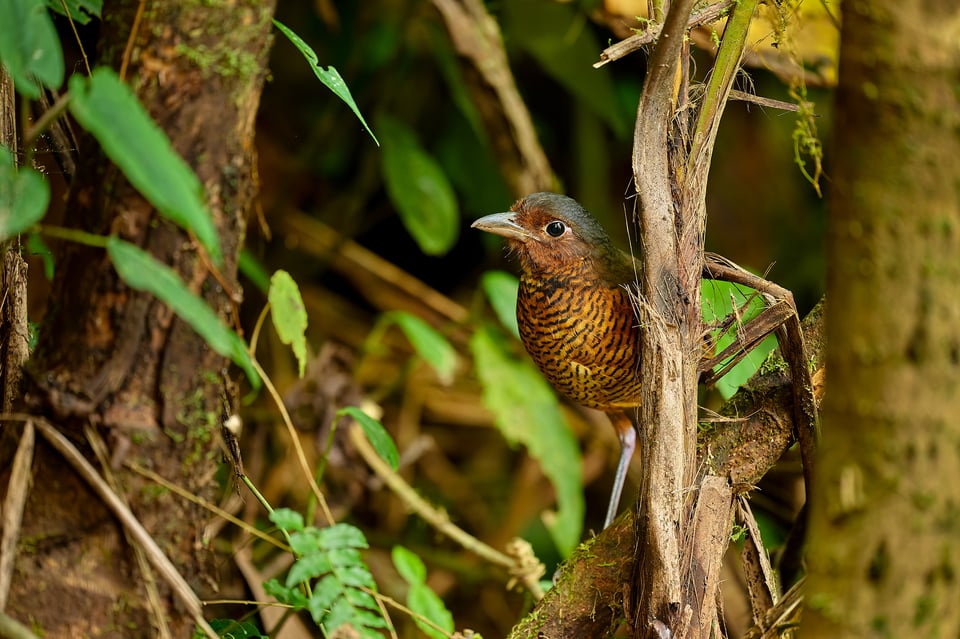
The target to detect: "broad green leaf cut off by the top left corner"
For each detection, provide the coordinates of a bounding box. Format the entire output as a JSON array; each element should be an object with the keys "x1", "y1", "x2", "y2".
[{"x1": 0, "y1": 0, "x2": 63, "y2": 99}]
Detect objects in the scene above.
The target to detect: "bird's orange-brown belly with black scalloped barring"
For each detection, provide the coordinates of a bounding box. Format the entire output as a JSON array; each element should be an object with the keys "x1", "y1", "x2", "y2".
[{"x1": 517, "y1": 280, "x2": 640, "y2": 410}]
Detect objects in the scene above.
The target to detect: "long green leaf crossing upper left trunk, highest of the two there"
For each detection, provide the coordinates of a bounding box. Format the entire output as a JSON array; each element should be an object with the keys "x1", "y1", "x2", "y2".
[{"x1": 70, "y1": 71, "x2": 223, "y2": 264}]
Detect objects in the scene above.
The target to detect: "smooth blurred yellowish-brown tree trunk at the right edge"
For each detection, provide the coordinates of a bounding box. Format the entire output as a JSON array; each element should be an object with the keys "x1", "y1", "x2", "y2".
[{"x1": 803, "y1": 0, "x2": 960, "y2": 637}]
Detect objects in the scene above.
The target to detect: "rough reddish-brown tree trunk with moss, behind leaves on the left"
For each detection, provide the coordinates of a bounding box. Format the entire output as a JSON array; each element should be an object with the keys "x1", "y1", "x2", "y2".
[{"x1": 0, "y1": 0, "x2": 274, "y2": 637}]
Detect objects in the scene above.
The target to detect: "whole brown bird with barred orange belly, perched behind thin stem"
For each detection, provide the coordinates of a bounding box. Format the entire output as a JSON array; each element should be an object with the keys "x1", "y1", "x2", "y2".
[{"x1": 471, "y1": 193, "x2": 642, "y2": 528}]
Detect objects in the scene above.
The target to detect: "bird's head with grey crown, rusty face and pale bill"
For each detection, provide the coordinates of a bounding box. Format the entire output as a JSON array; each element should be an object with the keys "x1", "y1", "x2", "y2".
[{"x1": 471, "y1": 193, "x2": 616, "y2": 273}]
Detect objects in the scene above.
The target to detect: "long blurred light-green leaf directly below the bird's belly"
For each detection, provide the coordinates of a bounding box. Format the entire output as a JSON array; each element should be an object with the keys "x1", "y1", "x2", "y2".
[{"x1": 470, "y1": 327, "x2": 584, "y2": 556}]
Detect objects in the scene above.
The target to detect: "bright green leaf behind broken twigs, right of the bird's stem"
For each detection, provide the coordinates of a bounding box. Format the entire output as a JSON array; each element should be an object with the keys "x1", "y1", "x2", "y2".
[{"x1": 701, "y1": 280, "x2": 777, "y2": 399}]
